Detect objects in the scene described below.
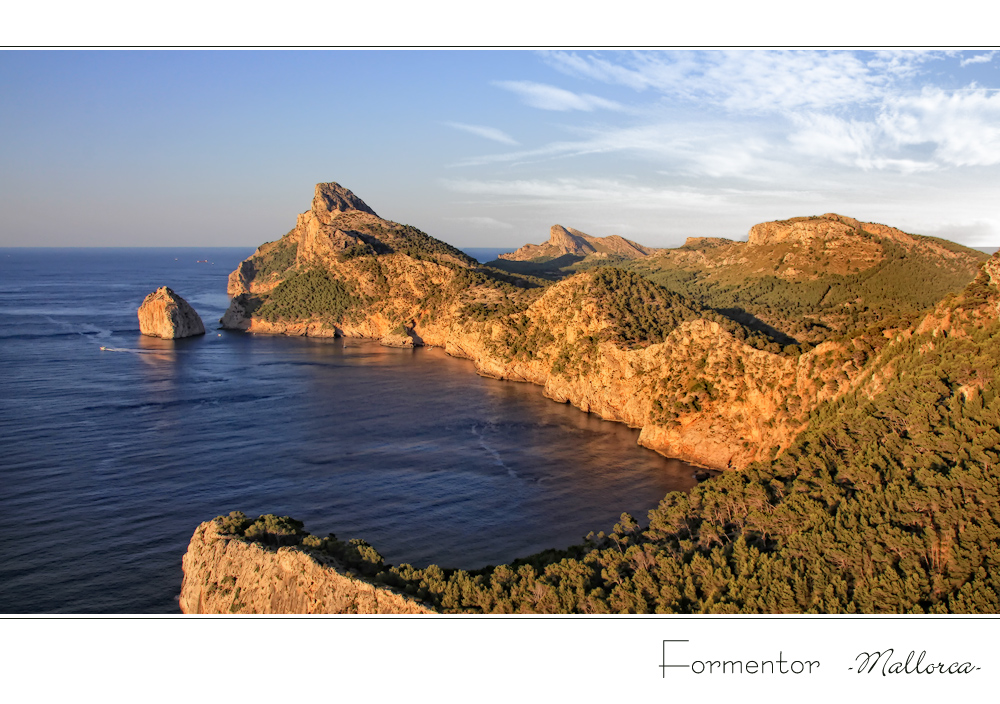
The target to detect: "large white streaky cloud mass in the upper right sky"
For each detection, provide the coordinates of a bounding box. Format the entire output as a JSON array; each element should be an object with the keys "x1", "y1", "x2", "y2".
[{"x1": 472, "y1": 51, "x2": 1000, "y2": 181}]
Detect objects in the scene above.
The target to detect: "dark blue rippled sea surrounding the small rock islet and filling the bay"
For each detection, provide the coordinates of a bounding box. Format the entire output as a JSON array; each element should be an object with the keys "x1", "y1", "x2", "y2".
[{"x1": 0, "y1": 248, "x2": 695, "y2": 614}]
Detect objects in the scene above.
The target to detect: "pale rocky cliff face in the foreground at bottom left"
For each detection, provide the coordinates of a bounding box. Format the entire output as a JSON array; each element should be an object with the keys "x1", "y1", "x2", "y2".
[{"x1": 180, "y1": 521, "x2": 432, "y2": 614}]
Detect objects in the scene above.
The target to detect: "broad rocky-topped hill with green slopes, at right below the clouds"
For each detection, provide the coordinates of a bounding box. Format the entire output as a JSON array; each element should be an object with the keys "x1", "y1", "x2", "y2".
[{"x1": 623, "y1": 213, "x2": 986, "y2": 344}]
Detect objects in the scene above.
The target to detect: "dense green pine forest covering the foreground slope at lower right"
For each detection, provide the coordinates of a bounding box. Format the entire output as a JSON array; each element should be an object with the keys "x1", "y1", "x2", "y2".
[{"x1": 398, "y1": 324, "x2": 1000, "y2": 613}]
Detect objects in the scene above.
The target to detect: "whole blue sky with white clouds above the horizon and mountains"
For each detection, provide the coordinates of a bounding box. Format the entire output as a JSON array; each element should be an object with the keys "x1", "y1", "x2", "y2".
[{"x1": 0, "y1": 50, "x2": 1000, "y2": 249}]
